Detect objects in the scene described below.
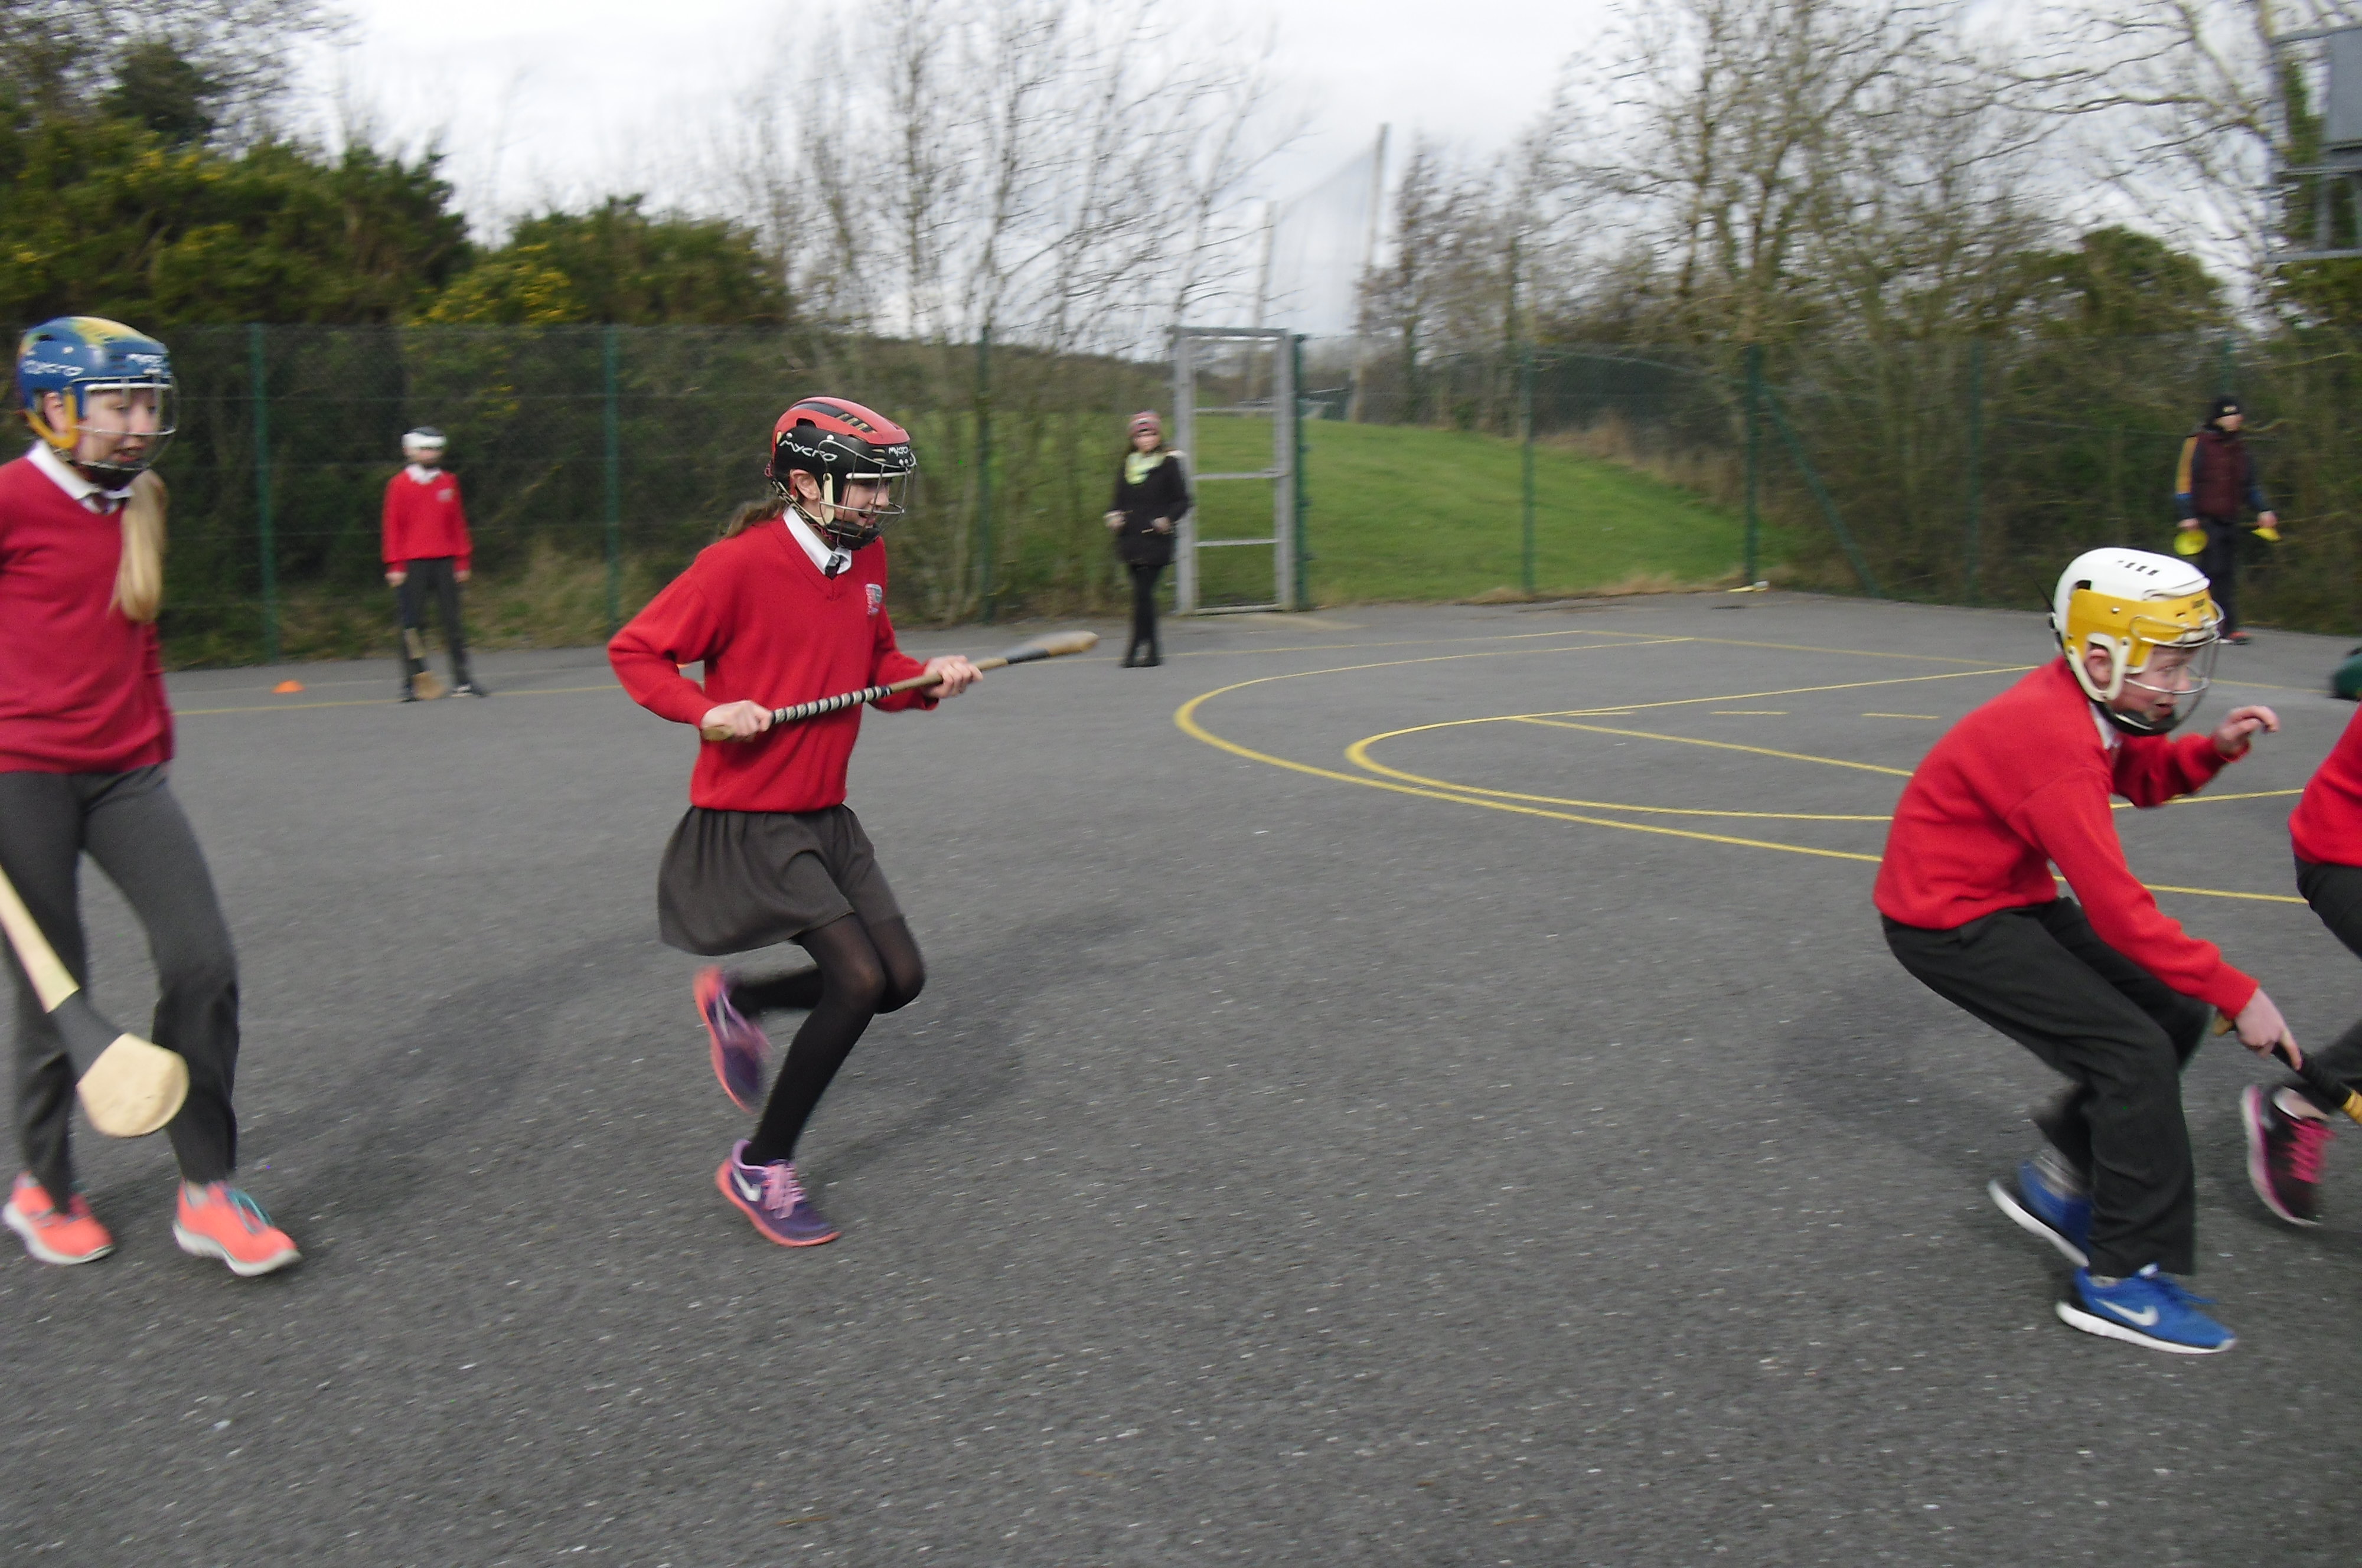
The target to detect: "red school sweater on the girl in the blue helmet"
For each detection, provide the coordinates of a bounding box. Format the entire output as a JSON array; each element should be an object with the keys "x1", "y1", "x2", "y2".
[{"x1": 0, "y1": 458, "x2": 172, "y2": 772}]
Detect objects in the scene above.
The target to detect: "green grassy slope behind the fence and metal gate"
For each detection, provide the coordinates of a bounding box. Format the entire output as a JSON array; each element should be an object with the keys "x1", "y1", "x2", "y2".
[{"x1": 1198, "y1": 418, "x2": 1743, "y2": 605}]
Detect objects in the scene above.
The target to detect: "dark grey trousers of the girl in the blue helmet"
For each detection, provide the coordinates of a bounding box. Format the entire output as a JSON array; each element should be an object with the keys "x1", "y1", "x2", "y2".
[{"x1": 0, "y1": 767, "x2": 239, "y2": 1202}]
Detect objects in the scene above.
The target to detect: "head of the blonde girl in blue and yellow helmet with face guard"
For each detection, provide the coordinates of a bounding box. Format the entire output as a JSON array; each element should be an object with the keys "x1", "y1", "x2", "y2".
[{"x1": 17, "y1": 316, "x2": 180, "y2": 484}]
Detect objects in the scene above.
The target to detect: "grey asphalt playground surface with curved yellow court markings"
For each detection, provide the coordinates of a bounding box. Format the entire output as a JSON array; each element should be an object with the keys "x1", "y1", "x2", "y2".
[{"x1": 14, "y1": 595, "x2": 2362, "y2": 1568}]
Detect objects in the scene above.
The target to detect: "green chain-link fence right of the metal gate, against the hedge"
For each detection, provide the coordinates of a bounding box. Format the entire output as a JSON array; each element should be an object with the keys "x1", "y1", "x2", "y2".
[{"x1": 1342, "y1": 335, "x2": 2362, "y2": 633}]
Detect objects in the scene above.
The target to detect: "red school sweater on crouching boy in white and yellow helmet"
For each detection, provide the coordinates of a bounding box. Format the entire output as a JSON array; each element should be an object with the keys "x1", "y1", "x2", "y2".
[{"x1": 1873, "y1": 659, "x2": 2256, "y2": 1013}]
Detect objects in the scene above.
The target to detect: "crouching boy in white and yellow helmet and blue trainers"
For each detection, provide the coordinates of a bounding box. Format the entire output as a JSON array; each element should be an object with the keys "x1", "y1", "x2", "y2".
[{"x1": 1875, "y1": 550, "x2": 2296, "y2": 1355}]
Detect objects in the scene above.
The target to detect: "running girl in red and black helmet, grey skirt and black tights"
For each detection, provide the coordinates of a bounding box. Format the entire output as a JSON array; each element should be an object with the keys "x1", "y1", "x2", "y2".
[{"x1": 607, "y1": 397, "x2": 978, "y2": 1247}]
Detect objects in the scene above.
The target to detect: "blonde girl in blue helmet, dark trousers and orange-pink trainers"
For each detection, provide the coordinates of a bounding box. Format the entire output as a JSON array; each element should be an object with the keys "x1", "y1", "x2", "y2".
[{"x1": 0, "y1": 316, "x2": 300, "y2": 1275}]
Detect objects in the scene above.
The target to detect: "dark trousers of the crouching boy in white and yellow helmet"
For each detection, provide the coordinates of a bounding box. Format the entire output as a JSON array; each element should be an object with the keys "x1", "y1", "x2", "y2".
[{"x1": 1885, "y1": 897, "x2": 2213, "y2": 1275}]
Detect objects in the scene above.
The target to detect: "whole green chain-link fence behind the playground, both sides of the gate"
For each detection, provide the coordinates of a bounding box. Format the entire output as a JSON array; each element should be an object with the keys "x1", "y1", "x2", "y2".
[{"x1": 18, "y1": 326, "x2": 2362, "y2": 664}]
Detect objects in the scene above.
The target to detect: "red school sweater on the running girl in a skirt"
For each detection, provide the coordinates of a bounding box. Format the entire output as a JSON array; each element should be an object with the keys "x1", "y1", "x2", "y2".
[{"x1": 607, "y1": 517, "x2": 935, "y2": 812}]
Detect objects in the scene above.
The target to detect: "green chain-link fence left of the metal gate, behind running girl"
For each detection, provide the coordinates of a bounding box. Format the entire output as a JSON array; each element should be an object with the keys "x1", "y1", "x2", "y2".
[{"x1": 0, "y1": 326, "x2": 1164, "y2": 664}]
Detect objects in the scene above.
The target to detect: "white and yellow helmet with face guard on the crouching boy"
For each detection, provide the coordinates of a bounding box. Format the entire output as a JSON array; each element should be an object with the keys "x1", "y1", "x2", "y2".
[{"x1": 2050, "y1": 548, "x2": 2223, "y2": 734}]
